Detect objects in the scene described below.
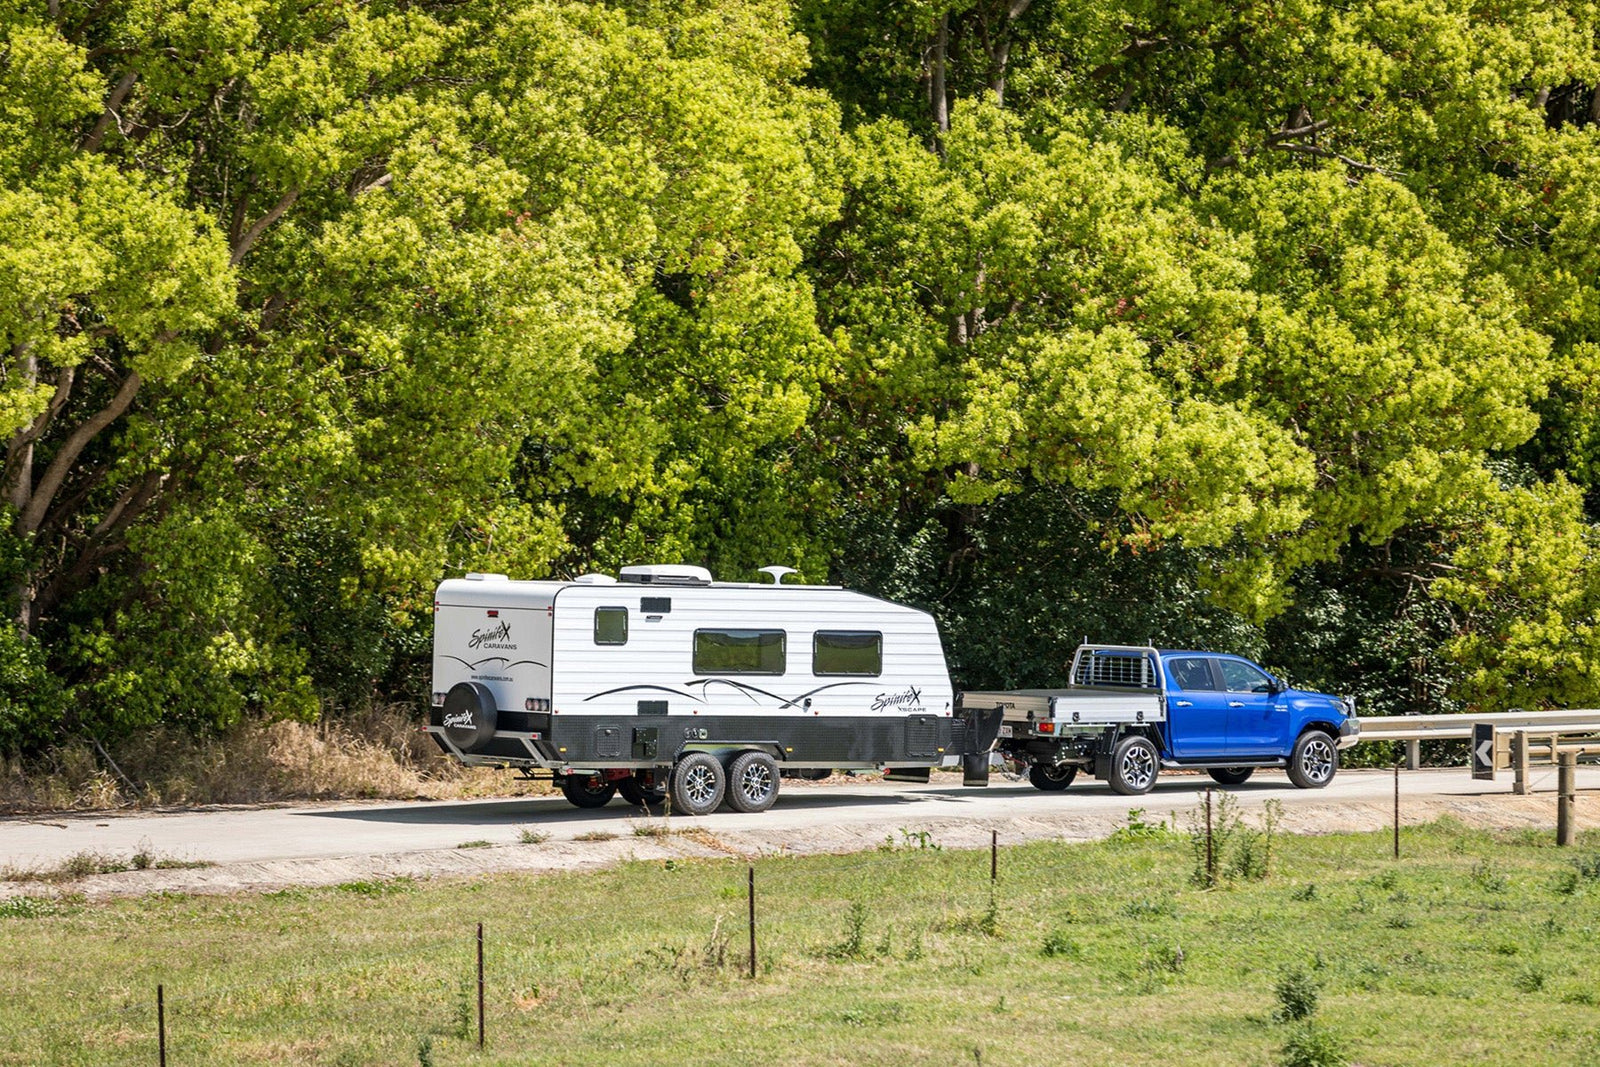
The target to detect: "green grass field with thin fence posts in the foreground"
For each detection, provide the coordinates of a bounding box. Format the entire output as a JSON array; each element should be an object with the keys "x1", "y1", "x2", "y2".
[{"x1": 0, "y1": 821, "x2": 1600, "y2": 1067}]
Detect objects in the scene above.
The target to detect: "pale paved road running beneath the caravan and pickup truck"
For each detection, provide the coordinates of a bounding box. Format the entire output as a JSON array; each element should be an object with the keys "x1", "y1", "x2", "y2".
[{"x1": 0, "y1": 768, "x2": 1600, "y2": 896}]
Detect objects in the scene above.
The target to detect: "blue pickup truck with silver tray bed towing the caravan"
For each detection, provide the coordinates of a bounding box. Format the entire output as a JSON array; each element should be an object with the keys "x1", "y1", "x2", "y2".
[{"x1": 962, "y1": 645, "x2": 1362, "y2": 795}]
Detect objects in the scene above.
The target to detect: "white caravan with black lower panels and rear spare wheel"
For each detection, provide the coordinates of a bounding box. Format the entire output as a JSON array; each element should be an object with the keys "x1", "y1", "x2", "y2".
[{"x1": 427, "y1": 566, "x2": 1000, "y2": 814}]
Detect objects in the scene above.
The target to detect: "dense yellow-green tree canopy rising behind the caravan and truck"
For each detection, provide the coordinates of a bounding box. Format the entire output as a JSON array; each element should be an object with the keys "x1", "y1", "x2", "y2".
[{"x1": 0, "y1": 0, "x2": 1600, "y2": 750}]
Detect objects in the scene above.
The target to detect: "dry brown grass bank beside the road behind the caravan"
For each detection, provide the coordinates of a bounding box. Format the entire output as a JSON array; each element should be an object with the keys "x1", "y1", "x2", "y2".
[{"x1": 0, "y1": 705, "x2": 549, "y2": 813}]
